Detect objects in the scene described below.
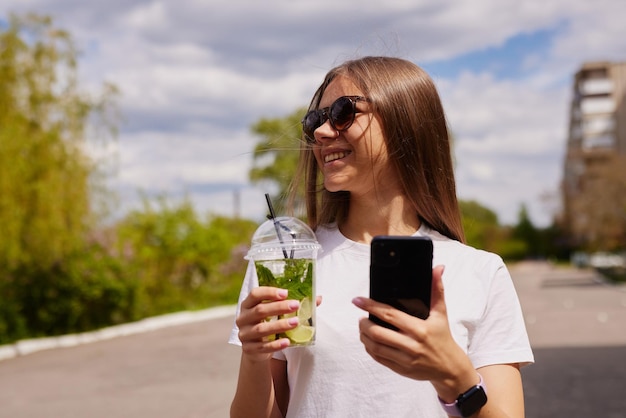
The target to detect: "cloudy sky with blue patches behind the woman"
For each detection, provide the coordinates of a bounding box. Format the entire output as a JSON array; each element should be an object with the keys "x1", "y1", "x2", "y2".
[{"x1": 0, "y1": 0, "x2": 626, "y2": 226}]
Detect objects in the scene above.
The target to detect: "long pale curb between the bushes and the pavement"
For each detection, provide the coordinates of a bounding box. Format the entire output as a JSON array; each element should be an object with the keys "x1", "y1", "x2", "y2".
[{"x1": 0, "y1": 305, "x2": 237, "y2": 361}]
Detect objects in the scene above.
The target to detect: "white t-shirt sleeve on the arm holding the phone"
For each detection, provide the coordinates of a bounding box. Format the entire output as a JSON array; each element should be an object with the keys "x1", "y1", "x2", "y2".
[{"x1": 468, "y1": 260, "x2": 534, "y2": 368}]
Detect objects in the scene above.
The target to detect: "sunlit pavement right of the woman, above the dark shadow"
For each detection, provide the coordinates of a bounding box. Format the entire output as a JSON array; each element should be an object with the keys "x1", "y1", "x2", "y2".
[{"x1": 511, "y1": 262, "x2": 626, "y2": 348}]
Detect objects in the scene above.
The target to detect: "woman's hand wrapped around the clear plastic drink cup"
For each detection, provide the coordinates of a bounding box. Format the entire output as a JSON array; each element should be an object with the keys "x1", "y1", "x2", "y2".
[{"x1": 235, "y1": 286, "x2": 300, "y2": 361}]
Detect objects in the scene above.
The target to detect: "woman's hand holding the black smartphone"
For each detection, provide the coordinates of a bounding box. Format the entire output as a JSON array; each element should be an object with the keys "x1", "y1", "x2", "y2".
[{"x1": 352, "y1": 266, "x2": 478, "y2": 400}]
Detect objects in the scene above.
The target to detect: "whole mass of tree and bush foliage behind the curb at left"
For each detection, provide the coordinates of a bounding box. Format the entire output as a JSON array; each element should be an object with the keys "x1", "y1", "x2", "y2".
[{"x1": 0, "y1": 15, "x2": 256, "y2": 344}]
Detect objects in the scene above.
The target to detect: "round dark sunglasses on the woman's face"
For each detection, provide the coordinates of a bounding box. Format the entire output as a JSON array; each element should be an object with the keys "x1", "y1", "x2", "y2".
[{"x1": 302, "y1": 96, "x2": 368, "y2": 144}]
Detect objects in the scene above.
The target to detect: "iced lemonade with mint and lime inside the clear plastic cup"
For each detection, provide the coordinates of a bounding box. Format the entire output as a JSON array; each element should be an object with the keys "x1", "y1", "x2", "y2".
[{"x1": 254, "y1": 258, "x2": 315, "y2": 346}]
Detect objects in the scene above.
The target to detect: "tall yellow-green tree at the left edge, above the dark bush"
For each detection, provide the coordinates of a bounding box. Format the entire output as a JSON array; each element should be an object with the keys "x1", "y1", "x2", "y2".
[{"x1": 0, "y1": 15, "x2": 115, "y2": 268}]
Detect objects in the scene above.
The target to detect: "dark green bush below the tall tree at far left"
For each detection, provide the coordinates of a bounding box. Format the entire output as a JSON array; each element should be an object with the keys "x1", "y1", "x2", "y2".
[{"x1": 0, "y1": 247, "x2": 136, "y2": 343}]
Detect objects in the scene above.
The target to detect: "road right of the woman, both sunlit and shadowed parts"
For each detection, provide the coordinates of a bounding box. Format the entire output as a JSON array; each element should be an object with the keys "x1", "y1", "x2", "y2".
[{"x1": 511, "y1": 263, "x2": 626, "y2": 418}]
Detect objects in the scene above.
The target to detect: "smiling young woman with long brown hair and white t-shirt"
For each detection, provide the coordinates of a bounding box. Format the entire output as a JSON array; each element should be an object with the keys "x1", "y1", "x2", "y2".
[{"x1": 230, "y1": 57, "x2": 533, "y2": 418}]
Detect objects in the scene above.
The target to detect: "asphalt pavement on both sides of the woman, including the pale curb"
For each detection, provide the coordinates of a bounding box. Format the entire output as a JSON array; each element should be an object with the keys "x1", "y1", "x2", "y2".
[{"x1": 0, "y1": 262, "x2": 626, "y2": 418}]
